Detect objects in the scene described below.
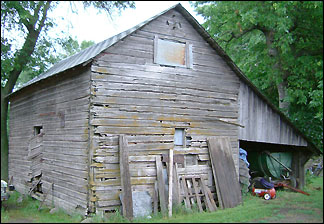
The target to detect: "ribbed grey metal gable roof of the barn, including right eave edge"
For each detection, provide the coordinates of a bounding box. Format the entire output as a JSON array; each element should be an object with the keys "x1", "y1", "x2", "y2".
[{"x1": 7, "y1": 3, "x2": 322, "y2": 154}]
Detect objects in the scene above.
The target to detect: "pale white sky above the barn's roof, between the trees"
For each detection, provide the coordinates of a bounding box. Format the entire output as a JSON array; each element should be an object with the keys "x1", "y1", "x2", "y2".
[{"x1": 49, "y1": 1, "x2": 203, "y2": 44}]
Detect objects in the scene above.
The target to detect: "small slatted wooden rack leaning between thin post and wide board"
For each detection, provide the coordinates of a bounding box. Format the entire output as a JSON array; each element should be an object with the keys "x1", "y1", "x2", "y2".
[{"x1": 180, "y1": 175, "x2": 217, "y2": 212}]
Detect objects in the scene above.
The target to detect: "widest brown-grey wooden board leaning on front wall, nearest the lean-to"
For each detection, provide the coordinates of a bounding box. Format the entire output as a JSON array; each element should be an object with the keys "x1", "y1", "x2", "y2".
[{"x1": 207, "y1": 137, "x2": 242, "y2": 208}]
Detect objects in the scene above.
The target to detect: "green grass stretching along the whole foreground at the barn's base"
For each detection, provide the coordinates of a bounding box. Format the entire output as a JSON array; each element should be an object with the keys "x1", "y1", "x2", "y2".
[{"x1": 1, "y1": 176, "x2": 323, "y2": 223}]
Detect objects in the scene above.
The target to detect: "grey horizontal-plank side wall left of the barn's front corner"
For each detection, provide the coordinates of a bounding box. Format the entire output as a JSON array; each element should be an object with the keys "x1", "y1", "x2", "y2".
[{"x1": 9, "y1": 68, "x2": 90, "y2": 213}]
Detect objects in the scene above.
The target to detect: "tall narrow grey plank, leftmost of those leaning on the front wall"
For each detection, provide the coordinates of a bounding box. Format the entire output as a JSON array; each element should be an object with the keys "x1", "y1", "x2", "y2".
[{"x1": 119, "y1": 135, "x2": 133, "y2": 219}]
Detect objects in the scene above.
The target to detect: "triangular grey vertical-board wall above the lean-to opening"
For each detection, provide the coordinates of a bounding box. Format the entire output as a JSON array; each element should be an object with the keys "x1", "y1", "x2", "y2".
[{"x1": 239, "y1": 81, "x2": 307, "y2": 146}]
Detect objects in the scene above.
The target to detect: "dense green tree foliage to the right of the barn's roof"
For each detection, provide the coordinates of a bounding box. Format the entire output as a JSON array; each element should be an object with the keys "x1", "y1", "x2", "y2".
[{"x1": 191, "y1": 1, "x2": 323, "y2": 151}]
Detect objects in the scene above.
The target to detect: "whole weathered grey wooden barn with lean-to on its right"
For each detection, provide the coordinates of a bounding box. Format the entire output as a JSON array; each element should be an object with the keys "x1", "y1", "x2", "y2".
[{"x1": 8, "y1": 4, "x2": 319, "y2": 216}]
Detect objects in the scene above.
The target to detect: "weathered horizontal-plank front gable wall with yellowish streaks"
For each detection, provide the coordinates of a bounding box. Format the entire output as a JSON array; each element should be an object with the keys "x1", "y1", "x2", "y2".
[{"x1": 90, "y1": 10, "x2": 239, "y2": 211}]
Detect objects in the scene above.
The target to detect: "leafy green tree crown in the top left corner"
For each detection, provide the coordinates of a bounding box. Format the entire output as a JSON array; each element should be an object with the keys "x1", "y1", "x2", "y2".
[{"x1": 1, "y1": 1, "x2": 57, "y2": 87}]
